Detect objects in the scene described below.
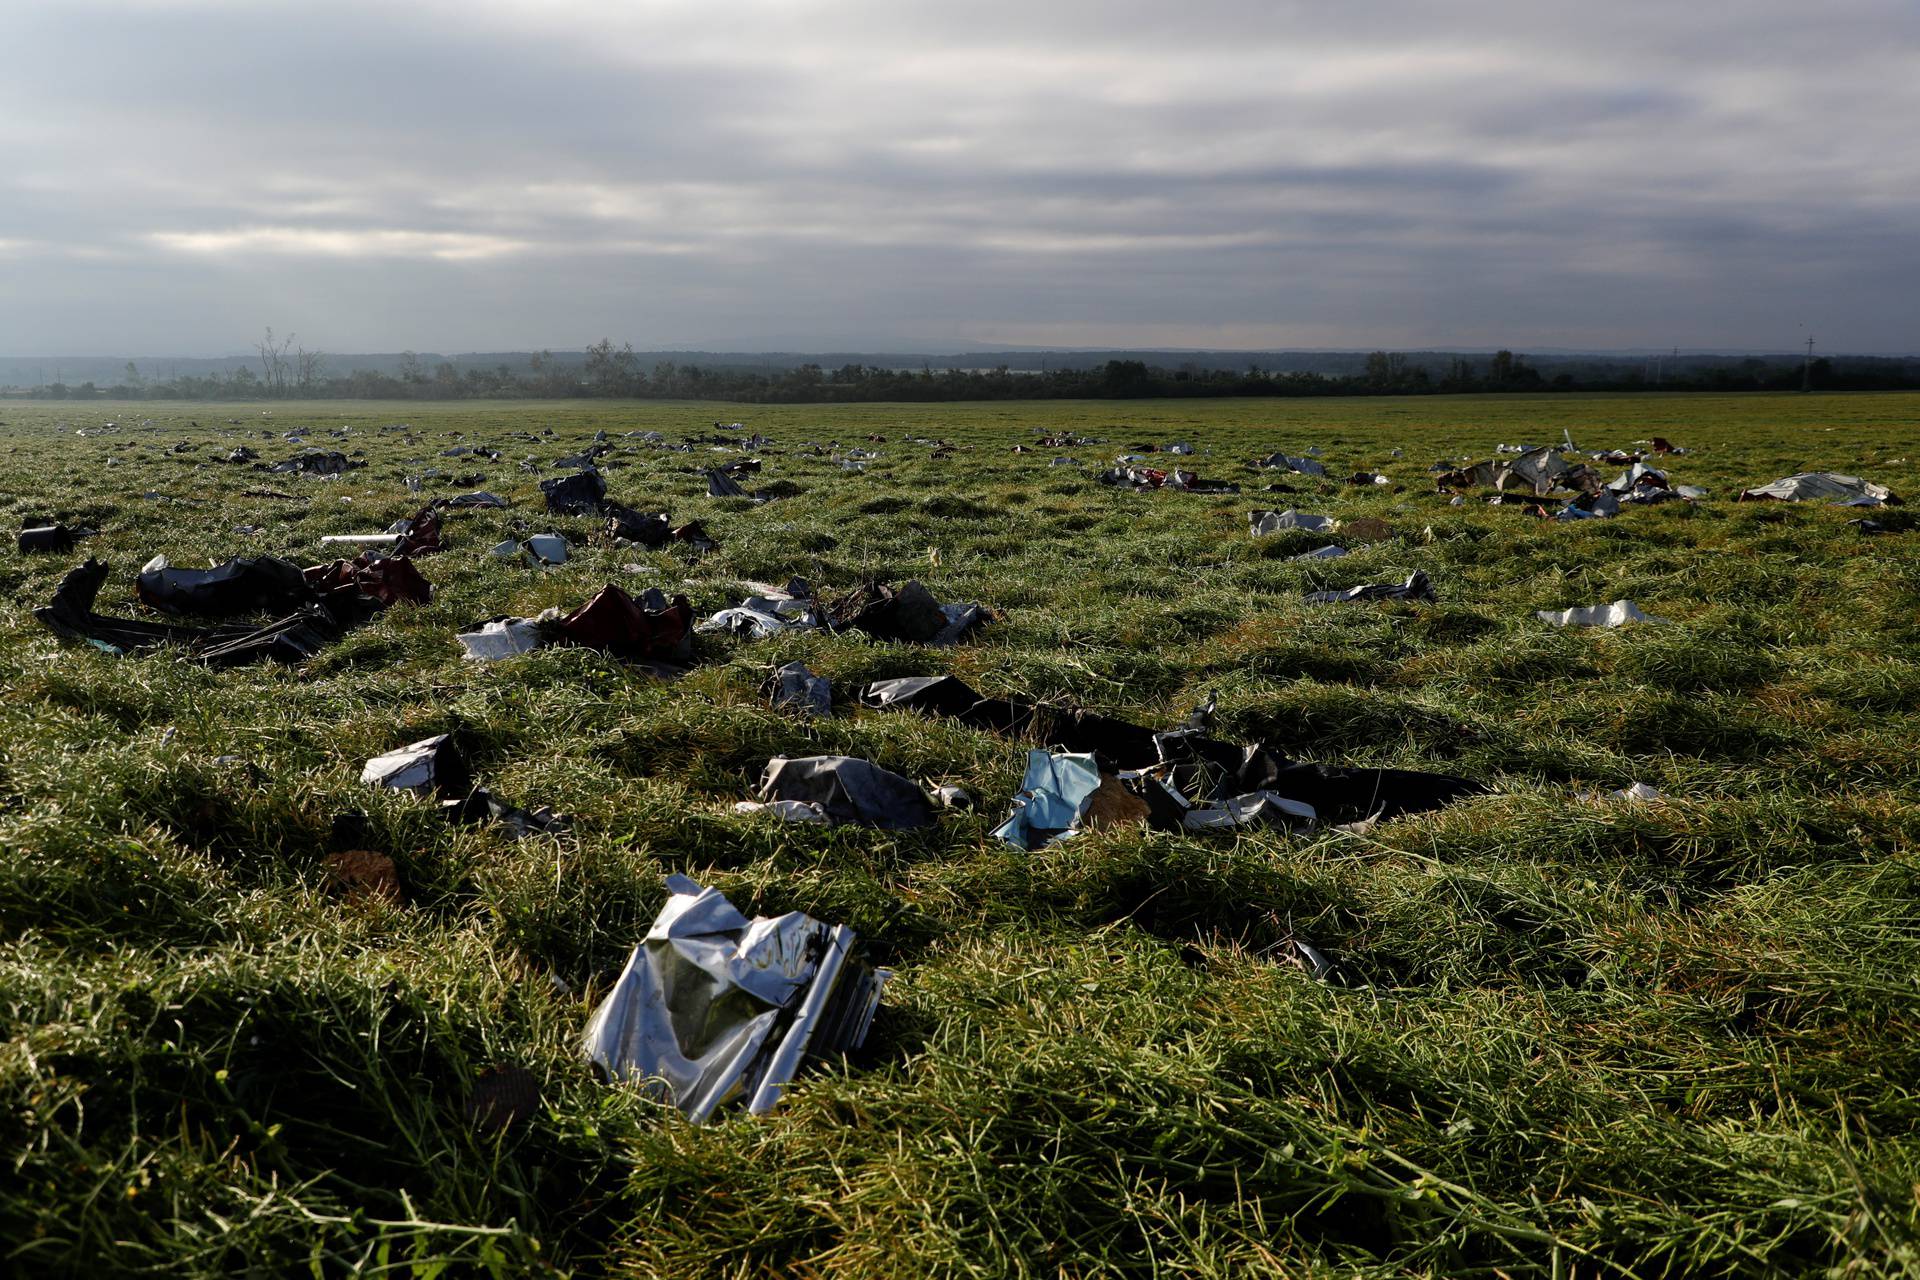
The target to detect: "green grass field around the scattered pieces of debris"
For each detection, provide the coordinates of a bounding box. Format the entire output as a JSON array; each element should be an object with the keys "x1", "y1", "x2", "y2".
[{"x1": 0, "y1": 395, "x2": 1920, "y2": 1280}]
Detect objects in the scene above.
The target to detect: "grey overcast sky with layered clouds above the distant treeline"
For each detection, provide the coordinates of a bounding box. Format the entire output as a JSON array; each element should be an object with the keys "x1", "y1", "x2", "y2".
[{"x1": 0, "y1": 0, "x2": 1920, "y2": 355}]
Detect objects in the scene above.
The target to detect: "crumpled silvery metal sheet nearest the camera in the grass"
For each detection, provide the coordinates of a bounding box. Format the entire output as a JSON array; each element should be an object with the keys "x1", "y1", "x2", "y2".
[{"x1": 584, "y1": 875, "x2": 891, "y2": 1125}]
